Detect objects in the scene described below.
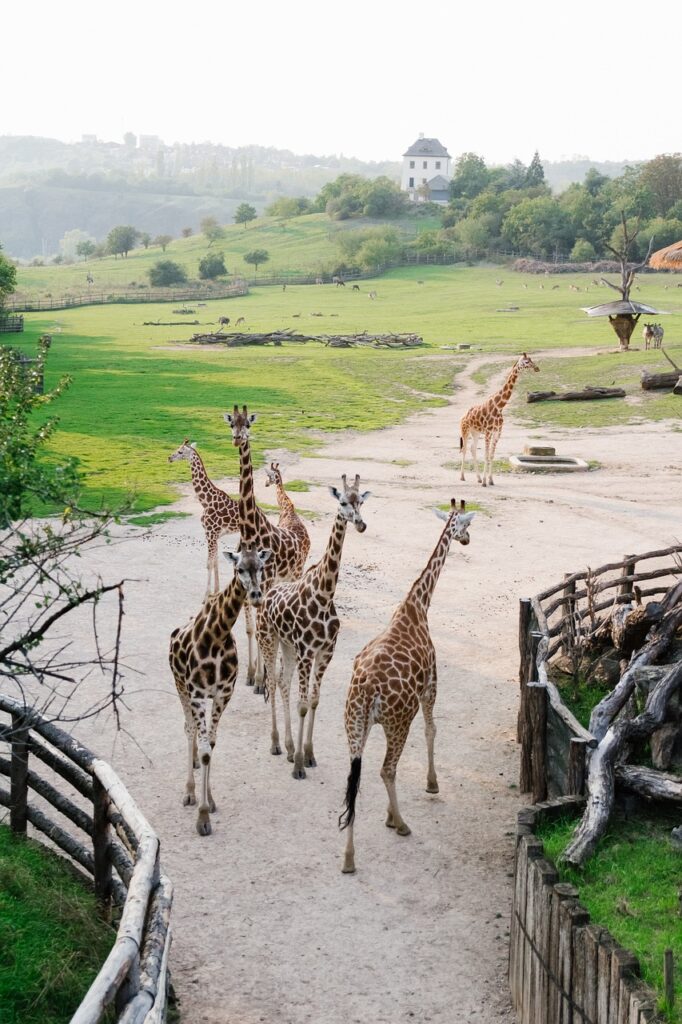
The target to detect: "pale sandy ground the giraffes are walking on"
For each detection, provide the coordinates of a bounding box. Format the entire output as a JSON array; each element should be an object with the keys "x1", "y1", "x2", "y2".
[{"x1": 33, "y1": 352, "x2": 682, "y2": 1024}]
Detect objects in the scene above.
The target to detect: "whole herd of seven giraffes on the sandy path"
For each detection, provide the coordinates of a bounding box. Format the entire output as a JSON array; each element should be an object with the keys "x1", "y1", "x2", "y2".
[{"x1": 169, "y1": 353, "x2": 538, "y2": 873}]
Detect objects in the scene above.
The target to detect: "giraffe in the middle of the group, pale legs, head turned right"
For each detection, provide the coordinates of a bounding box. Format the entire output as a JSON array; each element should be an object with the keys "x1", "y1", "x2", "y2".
[{"x1": 258, "y1": 473, "x2": 370, "y2": 778}]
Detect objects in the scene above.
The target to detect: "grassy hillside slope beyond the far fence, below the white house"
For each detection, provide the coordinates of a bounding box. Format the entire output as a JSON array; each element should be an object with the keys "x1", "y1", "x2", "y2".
[{"x1": 17, "y1": 213, "x2": 435, "y2": 298}]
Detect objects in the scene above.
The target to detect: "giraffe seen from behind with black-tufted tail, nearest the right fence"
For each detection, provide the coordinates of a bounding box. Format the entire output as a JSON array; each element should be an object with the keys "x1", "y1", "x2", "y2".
[{"x1": 339, "y1": 498, "x2": 474, "y2": 874}]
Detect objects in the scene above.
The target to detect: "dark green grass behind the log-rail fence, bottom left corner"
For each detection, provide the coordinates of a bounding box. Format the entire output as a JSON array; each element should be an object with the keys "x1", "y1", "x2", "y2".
[{"x1": 0, "y1": 825, "x2": 115, "y2": 1024}]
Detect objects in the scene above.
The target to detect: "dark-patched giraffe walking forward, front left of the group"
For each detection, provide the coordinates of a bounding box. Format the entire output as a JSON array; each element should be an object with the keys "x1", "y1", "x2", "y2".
[{"x1": 168, "y1": 543, "x2": 272, "y2": 836}]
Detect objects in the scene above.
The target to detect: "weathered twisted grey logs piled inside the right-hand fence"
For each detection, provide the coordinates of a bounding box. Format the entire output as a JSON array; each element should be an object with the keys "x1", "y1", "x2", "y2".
[{"x1": 562, "y1": 582, "x2": 682, "y2": 866}]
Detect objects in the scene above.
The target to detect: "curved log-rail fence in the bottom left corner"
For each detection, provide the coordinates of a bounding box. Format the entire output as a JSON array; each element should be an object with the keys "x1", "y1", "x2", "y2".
[{"x1": 0, "y1": 694, "x2": 173, "y2": 1024}]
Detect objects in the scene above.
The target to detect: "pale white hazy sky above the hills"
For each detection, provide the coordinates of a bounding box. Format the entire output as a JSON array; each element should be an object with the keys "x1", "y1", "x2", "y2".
[{"x1": 0, "y1": 0, "x2": 682, "y2": 163}]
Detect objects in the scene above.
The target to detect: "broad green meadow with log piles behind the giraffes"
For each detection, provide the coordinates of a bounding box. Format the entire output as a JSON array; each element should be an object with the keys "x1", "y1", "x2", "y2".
[{"x1": 7, "y1": 262, "x2": 682, "y2": 512}]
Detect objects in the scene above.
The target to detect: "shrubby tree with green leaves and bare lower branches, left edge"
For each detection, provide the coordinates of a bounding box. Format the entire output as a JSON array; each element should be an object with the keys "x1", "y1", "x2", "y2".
[{"x1": 0, "y1": 338, "x2": 123, "y2": 719}]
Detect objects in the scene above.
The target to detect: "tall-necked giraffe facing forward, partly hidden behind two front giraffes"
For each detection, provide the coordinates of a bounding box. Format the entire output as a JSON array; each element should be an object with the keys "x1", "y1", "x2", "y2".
[{"x1": 223, "y1": 404, "x2": 310, "y2": 693}]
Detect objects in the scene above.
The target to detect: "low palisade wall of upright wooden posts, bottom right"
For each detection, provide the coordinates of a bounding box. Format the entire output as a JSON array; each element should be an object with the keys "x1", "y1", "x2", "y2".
[{"x1": 509, "y1": 797, "x2": 657, "y2": 1024}]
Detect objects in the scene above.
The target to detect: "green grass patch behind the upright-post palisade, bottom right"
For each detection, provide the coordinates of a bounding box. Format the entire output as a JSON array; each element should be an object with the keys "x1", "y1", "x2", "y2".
[{"x1": 538, "y1": 814, "x2": 682, "y2": 1024}]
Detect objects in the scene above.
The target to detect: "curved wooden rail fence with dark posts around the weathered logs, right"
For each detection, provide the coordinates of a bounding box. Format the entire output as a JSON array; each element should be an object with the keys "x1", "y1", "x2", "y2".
[{"x1": 517, "y1": 544, "x2": 682, "y2": 803}]
